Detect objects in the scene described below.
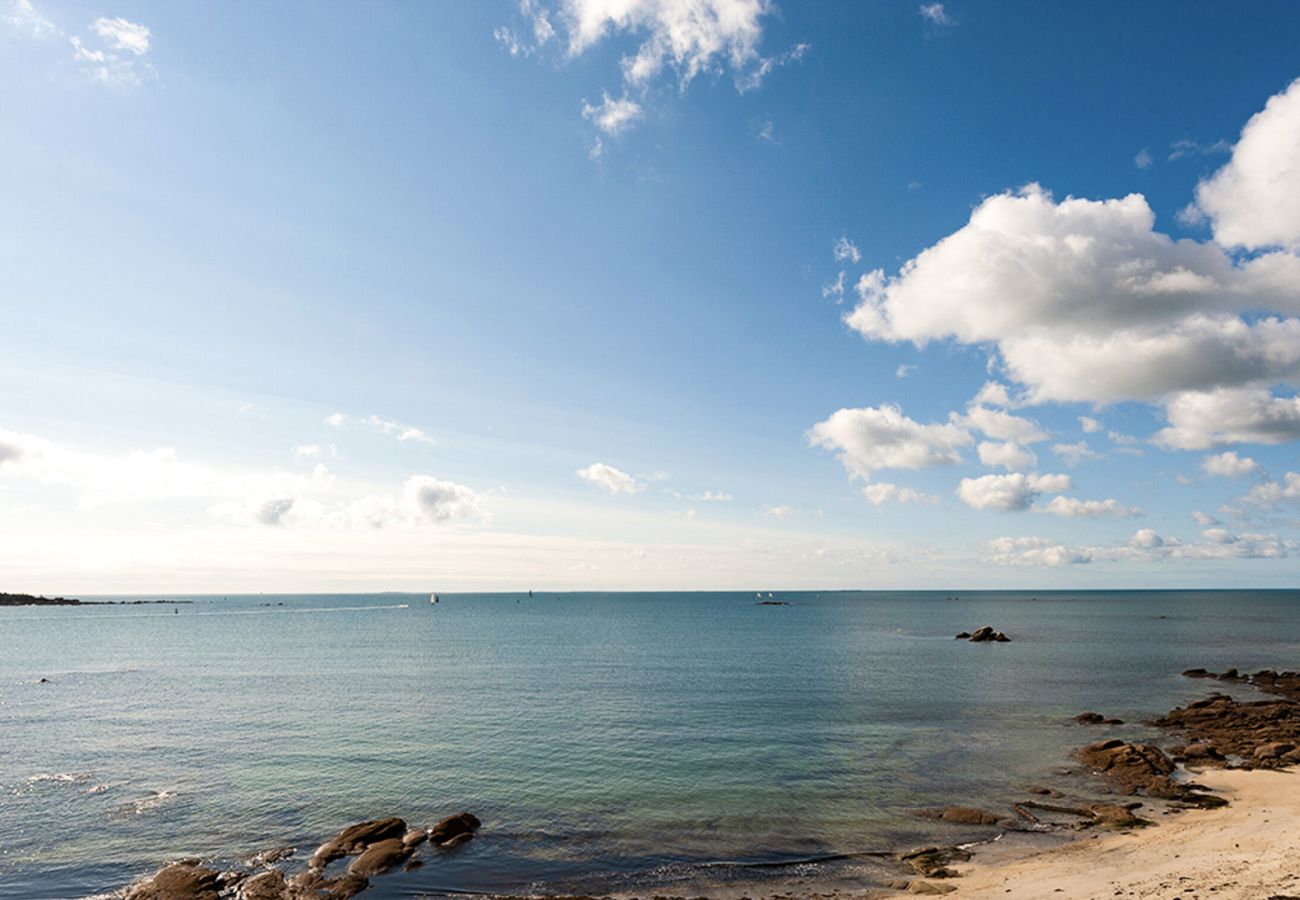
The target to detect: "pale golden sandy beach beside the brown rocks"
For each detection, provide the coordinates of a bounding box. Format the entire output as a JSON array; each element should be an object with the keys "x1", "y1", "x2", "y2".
[{"x1": 948, "y1": 769, "x2": 1300, "y2": 900}]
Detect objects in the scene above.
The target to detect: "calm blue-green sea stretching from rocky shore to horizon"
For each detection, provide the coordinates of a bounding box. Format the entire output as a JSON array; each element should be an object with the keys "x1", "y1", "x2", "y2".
[{"x1": 0, "y1": 590, "x2": 1300, "y2": 900}]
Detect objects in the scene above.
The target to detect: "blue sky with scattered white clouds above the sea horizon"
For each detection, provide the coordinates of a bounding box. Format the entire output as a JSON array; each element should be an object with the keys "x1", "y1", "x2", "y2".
[{"x1": 0, "y1": 0, "x2": 1300, "y2": 594}]
